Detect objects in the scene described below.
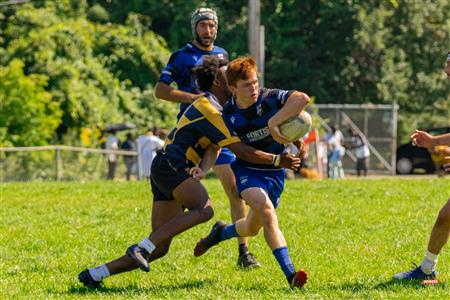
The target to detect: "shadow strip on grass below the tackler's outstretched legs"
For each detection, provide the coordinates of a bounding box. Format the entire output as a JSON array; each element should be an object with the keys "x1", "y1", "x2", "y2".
[{"x1": 66, "y1": 280, "x2": 213, "y2": 295}]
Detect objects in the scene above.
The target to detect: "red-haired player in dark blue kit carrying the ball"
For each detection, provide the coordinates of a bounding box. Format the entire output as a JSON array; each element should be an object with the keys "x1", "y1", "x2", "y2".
[{"x1": 194, "y1": 57, "x2": 309, "y2": 288}]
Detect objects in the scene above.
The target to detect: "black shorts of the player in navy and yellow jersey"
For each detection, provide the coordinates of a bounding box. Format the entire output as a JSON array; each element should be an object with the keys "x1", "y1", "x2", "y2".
[{"x1": 150, "y1": 152, "x2": 191, "y2": 201}]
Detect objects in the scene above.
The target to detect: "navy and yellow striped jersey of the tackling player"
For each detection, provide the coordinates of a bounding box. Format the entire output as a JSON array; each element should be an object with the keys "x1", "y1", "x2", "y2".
[{"x1": 162, "y1": 93, "x2": 240, "y2": 170}]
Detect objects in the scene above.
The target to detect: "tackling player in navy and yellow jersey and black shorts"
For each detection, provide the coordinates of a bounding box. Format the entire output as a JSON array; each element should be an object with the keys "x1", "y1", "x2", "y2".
[{"x1": 78, "y1": 58, "x2": 300, "y2": 288}]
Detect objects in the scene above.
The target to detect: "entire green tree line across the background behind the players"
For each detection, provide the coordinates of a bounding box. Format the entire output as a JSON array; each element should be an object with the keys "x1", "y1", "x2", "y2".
[{"x1": 0, "y1": 0, "x2": 450, "y2": 146}]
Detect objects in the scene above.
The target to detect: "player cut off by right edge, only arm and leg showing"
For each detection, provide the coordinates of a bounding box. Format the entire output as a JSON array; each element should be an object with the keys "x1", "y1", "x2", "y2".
[{"x1": 394, "y1": 51, "x2": 450, "y2": 283}]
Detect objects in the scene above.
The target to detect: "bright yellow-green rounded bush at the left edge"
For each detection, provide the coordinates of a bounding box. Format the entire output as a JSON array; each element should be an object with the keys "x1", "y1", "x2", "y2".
[{"x1": 0, "y1": 59, "x2": 61, "y2": 147}]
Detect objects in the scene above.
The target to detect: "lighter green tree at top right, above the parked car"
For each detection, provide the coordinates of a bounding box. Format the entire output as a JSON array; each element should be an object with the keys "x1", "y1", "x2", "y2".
[{"x1": 357, "y1": 0, "x2": 450, "y2": 136}]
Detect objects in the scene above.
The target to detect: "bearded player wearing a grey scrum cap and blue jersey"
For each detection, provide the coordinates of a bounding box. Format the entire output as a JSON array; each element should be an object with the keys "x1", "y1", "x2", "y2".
[{"x1": 155, "y1": 8, "x2": 260, "y2": 268}]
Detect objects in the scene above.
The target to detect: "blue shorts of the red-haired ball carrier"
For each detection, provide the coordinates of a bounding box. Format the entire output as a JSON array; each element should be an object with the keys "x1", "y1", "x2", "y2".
[{"x1": 231, "y1": 162, "x2": 286, "y2": 208}]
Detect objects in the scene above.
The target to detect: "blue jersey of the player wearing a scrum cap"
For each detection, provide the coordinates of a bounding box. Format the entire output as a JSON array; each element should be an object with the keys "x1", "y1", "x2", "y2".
[{"x1": 159, "y1": 43, "x2": 228, "y2": 119}]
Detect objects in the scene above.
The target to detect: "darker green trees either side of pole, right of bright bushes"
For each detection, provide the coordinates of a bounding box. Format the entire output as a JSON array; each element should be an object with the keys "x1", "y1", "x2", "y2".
[{"x1": 92, "y1": 0, "x2": 450, "y2": 136}]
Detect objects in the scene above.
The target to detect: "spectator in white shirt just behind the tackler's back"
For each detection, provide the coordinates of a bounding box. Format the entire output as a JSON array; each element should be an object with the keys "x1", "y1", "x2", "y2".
[{"x1": 137, "y1": 128, "x2": 164, "y2": 178}]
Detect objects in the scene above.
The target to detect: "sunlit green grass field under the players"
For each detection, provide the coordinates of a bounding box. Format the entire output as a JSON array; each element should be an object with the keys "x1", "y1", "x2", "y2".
[{"x1": 0, "y1": 178, "x2": 450, "y2": 300}]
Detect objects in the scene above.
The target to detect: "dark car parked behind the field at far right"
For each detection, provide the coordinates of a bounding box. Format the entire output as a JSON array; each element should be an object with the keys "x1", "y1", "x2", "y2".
[{"x1": 397, "y1": 127, "x2": 450, "y2": 174}]
